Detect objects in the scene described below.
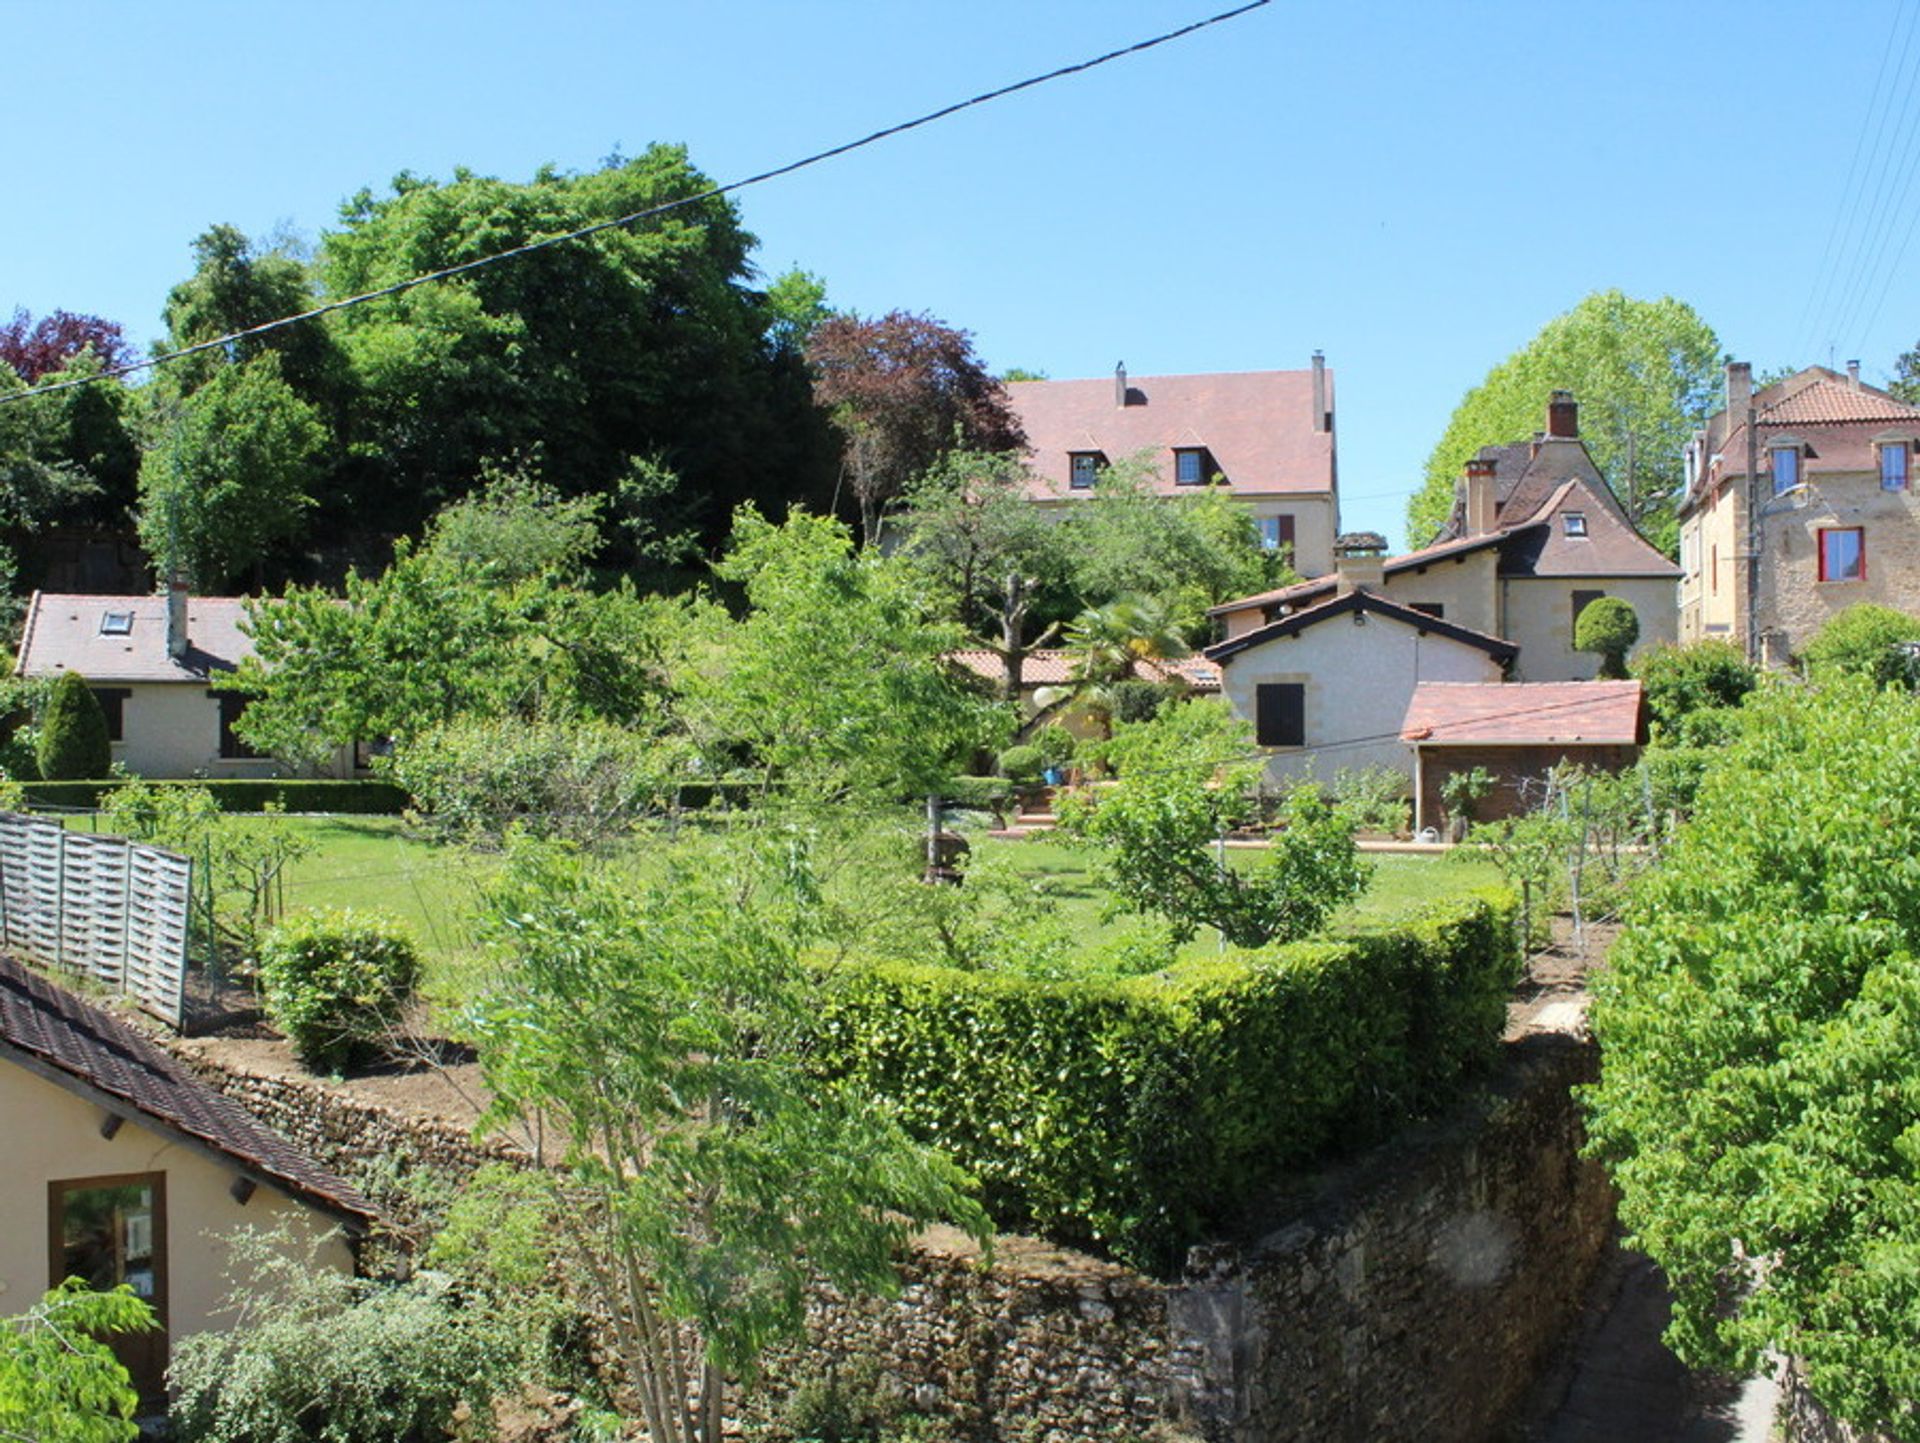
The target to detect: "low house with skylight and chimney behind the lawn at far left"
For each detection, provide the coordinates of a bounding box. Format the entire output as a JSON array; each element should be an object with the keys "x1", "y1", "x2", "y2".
[{"x1": 13, "y1": 585, "x2": 353, "y2": 779}]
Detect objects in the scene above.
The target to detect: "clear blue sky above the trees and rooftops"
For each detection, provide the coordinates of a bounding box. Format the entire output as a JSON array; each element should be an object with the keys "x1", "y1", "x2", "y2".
[{"x1": 0, "y1": 0, "x2": 1920, "y2": 537}]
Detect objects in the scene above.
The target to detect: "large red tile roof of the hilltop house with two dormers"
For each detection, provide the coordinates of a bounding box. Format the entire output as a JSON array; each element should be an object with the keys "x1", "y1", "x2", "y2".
[{"x1": 1006, "y1": 370, "x2": 1334, "y2": 499}]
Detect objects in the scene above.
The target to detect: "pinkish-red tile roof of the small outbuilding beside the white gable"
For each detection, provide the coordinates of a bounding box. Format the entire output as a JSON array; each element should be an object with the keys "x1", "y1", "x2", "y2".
[{"x1": 1400, "y1": 681, "x2": 1645, "y2": 746}]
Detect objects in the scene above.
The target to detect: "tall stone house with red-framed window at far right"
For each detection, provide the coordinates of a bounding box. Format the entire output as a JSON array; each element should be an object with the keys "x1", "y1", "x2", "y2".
[{"x1": 1680, "y1": 361, "x2": 1920, "y2": 664}]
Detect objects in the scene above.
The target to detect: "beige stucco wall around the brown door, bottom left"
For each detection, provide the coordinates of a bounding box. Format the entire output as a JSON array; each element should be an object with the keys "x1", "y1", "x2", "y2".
[{"x1": 0, "y1": 1061, "x2": 353, "y2": 1337}]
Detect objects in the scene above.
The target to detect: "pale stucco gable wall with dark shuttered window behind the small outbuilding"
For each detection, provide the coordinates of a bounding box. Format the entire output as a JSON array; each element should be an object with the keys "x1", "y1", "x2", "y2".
[{"x1": 1221, "y1": 612, "x2": 1501, "y2": 787}]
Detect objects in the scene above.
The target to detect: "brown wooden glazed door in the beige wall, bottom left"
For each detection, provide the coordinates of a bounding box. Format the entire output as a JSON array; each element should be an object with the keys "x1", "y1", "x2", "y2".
[{"x1": 48, "y1": 1172, "x2": 167, "y2": 1412}]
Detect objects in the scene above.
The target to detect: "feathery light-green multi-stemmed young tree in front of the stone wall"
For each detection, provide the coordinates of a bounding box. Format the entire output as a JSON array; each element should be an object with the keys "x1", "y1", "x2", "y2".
[{"x1": 470, "y1": 835, "x2": 985, "y2": 1443}]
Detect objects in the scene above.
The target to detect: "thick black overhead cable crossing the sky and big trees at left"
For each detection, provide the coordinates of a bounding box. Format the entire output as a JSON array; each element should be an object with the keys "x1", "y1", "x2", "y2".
[{"x1": 0, "y1": 0, "x2": 1273, "y2": 405}]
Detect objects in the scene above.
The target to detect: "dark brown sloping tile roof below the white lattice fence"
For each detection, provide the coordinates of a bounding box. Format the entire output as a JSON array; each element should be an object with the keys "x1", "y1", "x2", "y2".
[{"x1": 0, "y1": 956, "x2": 374, "y2": 1222}]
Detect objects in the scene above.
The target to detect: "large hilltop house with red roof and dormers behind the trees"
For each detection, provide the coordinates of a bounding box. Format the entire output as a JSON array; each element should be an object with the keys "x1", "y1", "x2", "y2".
[{"x1": 1006, "y1": 351, "x2": 1340, "y2": 576}]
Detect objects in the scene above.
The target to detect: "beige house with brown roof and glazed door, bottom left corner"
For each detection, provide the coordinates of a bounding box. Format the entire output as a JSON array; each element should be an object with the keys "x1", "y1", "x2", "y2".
[{"x1": 0, "y1": 956, "x2": 372, "y2": 1408}]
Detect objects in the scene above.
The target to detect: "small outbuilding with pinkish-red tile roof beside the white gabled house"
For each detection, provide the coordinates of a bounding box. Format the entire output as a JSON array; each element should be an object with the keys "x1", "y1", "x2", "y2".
[{"x1": 1400, "y1": 681, "x2": 1647, "y2": 833}]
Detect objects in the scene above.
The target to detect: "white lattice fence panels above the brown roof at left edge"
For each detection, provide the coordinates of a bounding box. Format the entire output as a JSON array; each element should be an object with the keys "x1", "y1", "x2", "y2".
[{"x1": 0, "y1": 812, "x2": 194, "y2": 1027}]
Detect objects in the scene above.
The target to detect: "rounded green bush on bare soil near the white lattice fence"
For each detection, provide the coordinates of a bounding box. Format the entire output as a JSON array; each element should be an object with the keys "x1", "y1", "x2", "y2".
[{"x1": 259, "y1": 911, "x2": 420, "y2": 1073}]
